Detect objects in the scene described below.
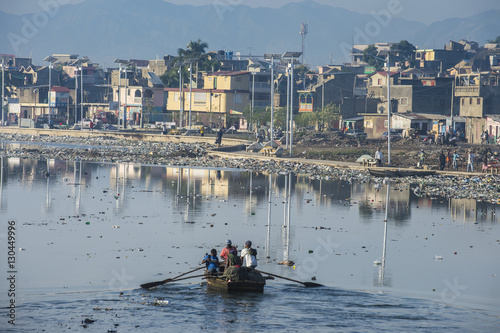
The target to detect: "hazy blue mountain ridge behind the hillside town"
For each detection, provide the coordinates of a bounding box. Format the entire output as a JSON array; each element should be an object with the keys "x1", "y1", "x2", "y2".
[{"x1": 0, "y1": 0, "x2": 500, "y2": 66}]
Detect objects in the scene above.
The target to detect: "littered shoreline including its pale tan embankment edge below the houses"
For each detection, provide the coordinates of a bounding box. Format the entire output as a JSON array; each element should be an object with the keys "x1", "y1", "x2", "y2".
[{"x1": 0, "y1": 129, "x2": 500, "y2": 204}]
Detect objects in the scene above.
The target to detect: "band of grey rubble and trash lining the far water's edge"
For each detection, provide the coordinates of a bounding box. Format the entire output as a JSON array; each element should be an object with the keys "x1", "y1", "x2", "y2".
[{"x1": 0, "y1": 134, "x2": 500, "y2": 204}]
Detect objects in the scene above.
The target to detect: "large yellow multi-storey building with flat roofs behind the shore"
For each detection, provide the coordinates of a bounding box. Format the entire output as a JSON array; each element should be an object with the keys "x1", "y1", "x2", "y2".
[{"x1": 165, "y1": 72, "x2": 250, "y2": 126}]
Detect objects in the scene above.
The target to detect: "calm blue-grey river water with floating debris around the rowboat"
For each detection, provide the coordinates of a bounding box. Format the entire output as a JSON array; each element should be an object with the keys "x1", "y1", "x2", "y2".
[{"x1": 0, "y1": 158, "x2": 500, "y2": 332}]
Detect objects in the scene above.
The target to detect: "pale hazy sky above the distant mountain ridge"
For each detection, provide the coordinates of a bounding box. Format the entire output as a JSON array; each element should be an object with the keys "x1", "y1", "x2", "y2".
[{"x1": 0, "y1": 0, "x2": 500, "y2": 23}]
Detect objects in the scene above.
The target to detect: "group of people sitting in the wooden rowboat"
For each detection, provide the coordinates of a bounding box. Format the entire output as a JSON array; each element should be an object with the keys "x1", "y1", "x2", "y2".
[{"x1": 202, "y1": 239, "x2": 257, "y2": 274}]
